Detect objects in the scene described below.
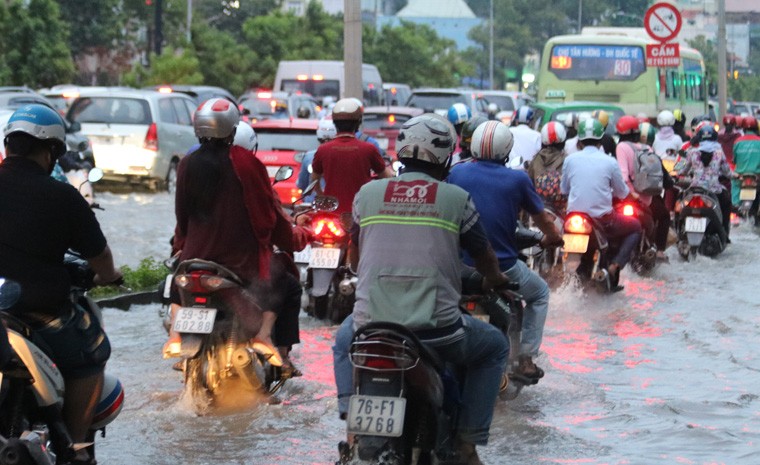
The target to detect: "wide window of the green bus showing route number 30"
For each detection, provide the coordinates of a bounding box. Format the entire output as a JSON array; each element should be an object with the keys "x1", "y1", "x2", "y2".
[{"x1": 549, "y1": 44, "x2": 646, "y2": 81}]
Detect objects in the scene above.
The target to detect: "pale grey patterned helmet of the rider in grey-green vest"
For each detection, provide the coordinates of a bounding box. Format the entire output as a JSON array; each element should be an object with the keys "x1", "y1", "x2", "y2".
[{"x1": 396, "y1": 113, "x2": 457, "y2": 165}]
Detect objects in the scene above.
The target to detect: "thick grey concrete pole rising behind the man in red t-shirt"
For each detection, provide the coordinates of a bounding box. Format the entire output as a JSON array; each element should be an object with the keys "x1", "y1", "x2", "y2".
[{"x1": 339, "y1": 0, "x2": 362, "y2": 100}]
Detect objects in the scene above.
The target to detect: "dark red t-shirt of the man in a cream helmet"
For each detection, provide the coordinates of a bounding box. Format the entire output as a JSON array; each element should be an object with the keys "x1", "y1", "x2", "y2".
[{"x1": 311, "y1": 134, "x2": 385, "y2": 213}]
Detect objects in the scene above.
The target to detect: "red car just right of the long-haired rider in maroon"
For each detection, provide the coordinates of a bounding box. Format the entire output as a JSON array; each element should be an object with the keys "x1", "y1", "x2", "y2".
[{"x1": 251, "y1": 118, "x2": 319, "y2": 206}]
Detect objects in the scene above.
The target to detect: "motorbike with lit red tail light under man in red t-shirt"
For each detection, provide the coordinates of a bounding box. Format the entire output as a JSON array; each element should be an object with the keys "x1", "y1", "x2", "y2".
[{"x1": 295, "y1": 195, "x2": 356, "y2": 324}]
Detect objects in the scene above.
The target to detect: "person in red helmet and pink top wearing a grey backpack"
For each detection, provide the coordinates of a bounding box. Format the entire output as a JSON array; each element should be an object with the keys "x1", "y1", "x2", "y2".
[{"x1": 615, "y1": 112, "x2": 680, "y2": 261}]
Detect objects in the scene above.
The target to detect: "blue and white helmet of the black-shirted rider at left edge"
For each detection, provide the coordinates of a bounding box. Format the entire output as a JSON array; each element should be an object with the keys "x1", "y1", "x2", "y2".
[{"x1": 3, "y1": 103, "x2": 66, "y2": 158}]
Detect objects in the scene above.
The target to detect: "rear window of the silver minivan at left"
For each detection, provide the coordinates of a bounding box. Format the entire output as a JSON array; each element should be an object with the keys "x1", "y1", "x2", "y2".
[{"x1": 68, "y1": 96, "x2": 153, "y2": 125}]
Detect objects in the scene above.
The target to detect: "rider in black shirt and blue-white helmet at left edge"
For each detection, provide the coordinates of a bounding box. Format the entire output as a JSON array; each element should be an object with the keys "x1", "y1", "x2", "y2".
[{"x1": 0, "y1": 104, "x2": 121, "y2": 464}]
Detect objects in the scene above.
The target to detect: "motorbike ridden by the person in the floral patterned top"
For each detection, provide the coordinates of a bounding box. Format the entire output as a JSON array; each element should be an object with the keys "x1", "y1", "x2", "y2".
[{"x1": 674, "y1": 187, "x2": 728, "y2": 260}]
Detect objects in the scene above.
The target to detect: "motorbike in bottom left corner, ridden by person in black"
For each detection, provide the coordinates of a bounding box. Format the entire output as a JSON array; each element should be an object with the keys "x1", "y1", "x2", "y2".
[{"x1": 0, "y1": 253, "x2": 124, "y2": 465}]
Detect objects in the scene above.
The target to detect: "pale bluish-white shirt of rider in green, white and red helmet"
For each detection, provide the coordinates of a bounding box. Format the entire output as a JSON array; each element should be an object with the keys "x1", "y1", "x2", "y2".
[{"x1": 560, "y1": 146, "x2": 629, "y2": 218}]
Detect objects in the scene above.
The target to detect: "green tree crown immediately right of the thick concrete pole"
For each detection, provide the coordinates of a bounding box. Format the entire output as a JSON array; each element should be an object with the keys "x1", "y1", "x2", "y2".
[{"x1": 362, "y1": 21, "x2": 472, "y2": 87}]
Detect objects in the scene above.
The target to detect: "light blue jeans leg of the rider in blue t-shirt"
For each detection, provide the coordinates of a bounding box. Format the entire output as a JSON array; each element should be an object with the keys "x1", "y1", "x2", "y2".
[{"x1": 506, "y1": 260, "x2": 549, "y2": 357}]
